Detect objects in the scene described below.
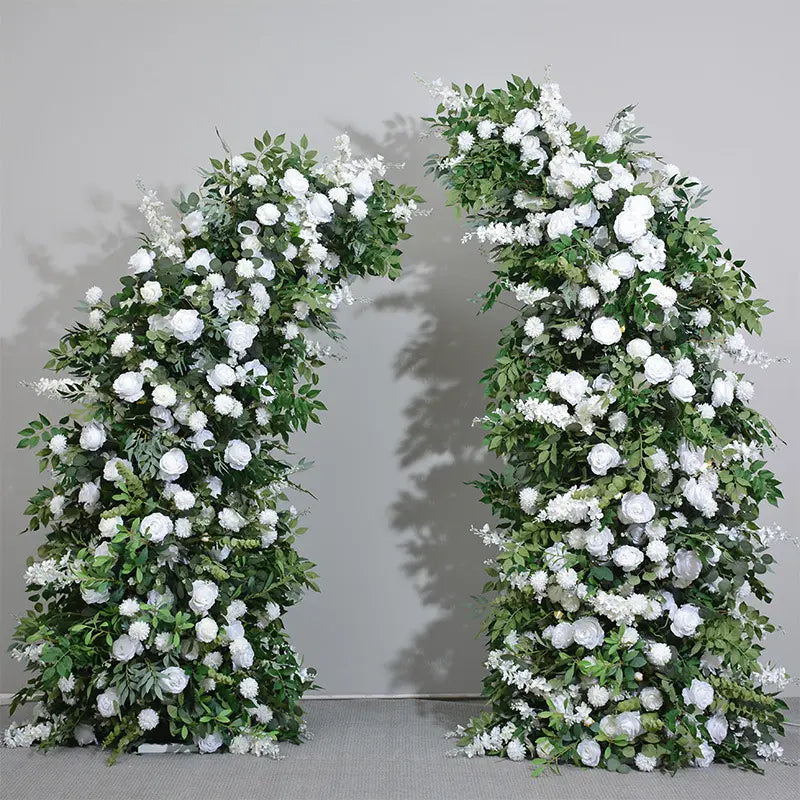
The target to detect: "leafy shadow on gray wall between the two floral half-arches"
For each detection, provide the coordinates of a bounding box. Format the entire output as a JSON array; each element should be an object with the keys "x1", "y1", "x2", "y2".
[{"x1": 338, "y1": 115, "x2": 506, "y2": 700}]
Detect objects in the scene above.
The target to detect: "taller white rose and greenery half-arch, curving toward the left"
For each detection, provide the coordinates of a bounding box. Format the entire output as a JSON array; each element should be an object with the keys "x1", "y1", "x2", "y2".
[{"x1": 427, "y1": 77, "x2": 786, "y2": 773}]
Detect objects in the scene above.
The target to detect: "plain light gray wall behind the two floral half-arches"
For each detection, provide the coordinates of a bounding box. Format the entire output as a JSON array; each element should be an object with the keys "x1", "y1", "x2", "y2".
[{"x1": 0, "y1": 0, "x2": 800, "y2": 693}]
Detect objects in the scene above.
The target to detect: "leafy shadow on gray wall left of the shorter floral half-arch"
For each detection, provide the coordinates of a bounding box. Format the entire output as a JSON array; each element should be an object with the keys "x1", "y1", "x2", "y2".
[{"x1": 0, "y1": 191, "x2": 167, "y2": 691}]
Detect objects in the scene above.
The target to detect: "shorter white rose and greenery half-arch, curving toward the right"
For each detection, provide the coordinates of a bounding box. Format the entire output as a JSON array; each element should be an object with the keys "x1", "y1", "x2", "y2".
[{"x1": 5, "y1": 134, "x2": 420, "y2": 756}]
